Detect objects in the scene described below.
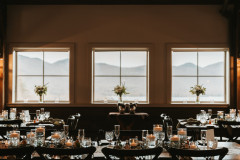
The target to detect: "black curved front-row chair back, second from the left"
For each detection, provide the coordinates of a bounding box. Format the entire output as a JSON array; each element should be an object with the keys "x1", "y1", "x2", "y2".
[{"x1": 36, "y1": 147, "x2": 96, "y2": 160}]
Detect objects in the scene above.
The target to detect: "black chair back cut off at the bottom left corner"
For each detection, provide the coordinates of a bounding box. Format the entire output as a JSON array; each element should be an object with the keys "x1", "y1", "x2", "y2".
[{"x1": 0, "y1": 146, "x2": 34, "y2": 160}]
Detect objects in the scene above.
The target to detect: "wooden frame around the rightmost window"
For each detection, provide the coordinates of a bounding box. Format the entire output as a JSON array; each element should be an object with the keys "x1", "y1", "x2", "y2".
[{"x1": 167, "y1": 44, "x2": 230, "y2": 105}]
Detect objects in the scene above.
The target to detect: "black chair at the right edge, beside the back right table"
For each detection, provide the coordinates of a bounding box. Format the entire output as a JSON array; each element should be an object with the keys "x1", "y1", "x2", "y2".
[{"x1": 218, "y1": 121, "x2": 240, "y2": 141}]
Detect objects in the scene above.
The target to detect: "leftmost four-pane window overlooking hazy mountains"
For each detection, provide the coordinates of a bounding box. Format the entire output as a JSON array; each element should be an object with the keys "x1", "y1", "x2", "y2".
[{"x1": 12, "y1": 48, "x2": 70, "y2": 103}]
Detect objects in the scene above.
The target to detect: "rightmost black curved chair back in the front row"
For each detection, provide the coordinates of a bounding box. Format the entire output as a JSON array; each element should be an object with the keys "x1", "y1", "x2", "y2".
[{"x1": 168, "y1": 147, "x2": 228, "y2": 160}]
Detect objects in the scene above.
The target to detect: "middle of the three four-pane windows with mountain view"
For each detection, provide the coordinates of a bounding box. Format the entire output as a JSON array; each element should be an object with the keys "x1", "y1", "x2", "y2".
[{"x1": 92, "y1": 48, "x2": 148, "y2": 103}]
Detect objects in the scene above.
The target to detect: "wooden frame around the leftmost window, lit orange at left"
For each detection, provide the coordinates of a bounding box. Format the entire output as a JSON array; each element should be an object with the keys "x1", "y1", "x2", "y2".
[{"x1": 6, "y1": 43, "x2": 74, "y2": 105}]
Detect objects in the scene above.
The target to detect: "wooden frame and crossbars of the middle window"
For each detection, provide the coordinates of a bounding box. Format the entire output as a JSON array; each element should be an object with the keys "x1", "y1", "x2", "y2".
[{"x1": 91, "y1": 47, "x2": 150, "y2": 104}]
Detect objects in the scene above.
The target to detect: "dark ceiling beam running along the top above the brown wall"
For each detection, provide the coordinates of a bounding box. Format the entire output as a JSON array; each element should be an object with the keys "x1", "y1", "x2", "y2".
[{"x1": 5, "y1": 0, "x2": 234, "y2": 5}]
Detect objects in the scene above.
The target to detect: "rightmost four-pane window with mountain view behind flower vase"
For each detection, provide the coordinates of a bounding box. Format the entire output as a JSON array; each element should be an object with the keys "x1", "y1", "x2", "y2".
[{"x1": 171, "y1": 48, "x2": 229, "y2": 103}]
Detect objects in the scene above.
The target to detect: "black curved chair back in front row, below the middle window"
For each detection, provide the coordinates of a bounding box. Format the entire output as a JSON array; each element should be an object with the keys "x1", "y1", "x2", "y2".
[{"x1": 102, "y1": 147, "x2": 163, "y2": 160}]
